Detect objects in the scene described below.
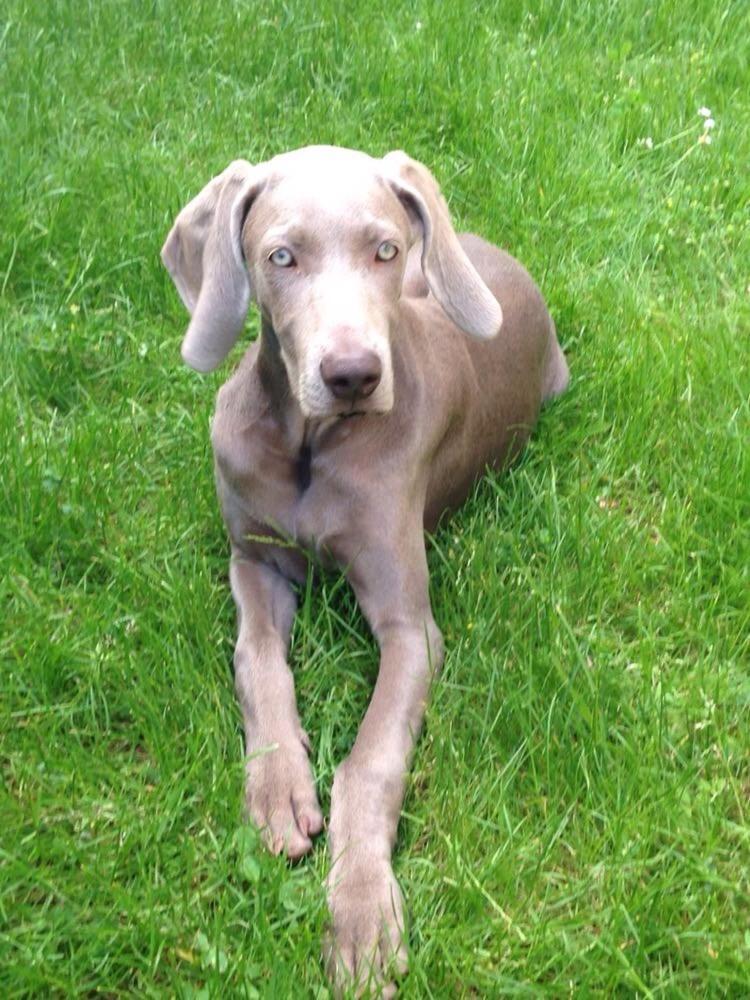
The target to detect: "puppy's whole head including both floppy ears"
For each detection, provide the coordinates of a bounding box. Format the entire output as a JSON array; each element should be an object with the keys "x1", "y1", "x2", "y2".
[{"x1": 162, "y1": 146, "x2": 502, "y2": 417}]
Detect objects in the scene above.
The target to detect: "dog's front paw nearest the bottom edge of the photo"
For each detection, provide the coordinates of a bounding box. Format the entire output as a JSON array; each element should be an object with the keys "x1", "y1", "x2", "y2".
[{"x1": 323, "y1": 858, "x2": 408, "y2": 997}]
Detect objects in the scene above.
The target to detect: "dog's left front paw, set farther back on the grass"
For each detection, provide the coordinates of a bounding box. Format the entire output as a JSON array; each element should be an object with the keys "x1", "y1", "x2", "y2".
[{"x1": 245, "y1": 735, "x2": 323, "y2": 860}]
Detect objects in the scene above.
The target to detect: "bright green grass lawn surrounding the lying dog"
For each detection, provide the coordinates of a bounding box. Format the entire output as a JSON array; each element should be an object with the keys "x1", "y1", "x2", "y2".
[{"x1": 0, "y1": 0, "x2": 750, "y2": 998}]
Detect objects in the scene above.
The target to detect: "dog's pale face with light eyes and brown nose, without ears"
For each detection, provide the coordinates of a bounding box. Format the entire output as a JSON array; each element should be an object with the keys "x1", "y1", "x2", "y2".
[{"x1": 242, "y1": 147, "x2": 417, "y2": 418}]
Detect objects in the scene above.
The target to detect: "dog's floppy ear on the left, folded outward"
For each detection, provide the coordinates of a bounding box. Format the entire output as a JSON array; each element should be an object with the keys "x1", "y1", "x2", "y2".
[{"x1": 161, "y1": 160, "x2": 265, "y2": 372}]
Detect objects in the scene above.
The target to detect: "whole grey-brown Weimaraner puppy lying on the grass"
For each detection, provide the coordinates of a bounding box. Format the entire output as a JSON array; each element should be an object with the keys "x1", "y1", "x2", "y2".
[{"x1": 162, "y1": 146, "x2": 568, "y2": 996}]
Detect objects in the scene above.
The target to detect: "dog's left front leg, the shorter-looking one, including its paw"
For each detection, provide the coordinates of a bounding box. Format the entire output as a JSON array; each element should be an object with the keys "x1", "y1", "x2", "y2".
[{"x1": 229, "y1": 552, "x2": 323, "y2": 858}]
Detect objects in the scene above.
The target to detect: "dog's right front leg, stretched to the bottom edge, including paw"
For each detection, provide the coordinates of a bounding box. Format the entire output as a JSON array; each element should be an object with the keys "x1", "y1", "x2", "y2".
[{"x1": 326, "y1": 519, "x2": 443, "y2": 996}]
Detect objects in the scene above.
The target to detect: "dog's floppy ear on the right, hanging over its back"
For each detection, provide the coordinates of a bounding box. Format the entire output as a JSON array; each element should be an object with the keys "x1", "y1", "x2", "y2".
[{"x1": 381, "y1": 150, "x2": 503, "y2": 340}]
